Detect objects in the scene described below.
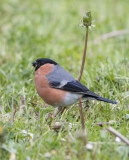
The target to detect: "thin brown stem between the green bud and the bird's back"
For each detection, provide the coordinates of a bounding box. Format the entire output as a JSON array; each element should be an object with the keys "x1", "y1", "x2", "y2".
[{"x1": 78, "y1": 27, "x2": 88, "y2": 81}]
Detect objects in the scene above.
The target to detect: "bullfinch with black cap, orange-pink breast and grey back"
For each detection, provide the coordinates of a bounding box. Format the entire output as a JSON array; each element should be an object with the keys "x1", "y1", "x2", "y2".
[{"x1": 32, "y1": 58, "x2": 117, "y2": 108}]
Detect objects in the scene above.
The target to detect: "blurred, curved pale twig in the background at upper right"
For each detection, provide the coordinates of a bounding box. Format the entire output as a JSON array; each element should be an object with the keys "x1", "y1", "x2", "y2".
[{"x1": 94, "y1": 30, "x2": 129, "y2": 44}]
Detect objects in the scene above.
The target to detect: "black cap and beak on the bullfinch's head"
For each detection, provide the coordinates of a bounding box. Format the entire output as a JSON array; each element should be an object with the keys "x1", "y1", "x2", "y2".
[{"x1": 32, "y1": 58, "x2": 57, "y2": 71}]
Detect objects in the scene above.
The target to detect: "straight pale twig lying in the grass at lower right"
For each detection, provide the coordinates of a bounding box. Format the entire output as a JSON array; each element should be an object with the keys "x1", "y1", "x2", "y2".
[{"x1": 106, "y1": 127, "x2": 129, "y2": 146}]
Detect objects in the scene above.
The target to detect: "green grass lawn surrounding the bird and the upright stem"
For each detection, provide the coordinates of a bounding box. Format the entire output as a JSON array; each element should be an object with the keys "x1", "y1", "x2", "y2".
[{"x1": 0, "y1": 0, "x2": 129, "y2": 160}]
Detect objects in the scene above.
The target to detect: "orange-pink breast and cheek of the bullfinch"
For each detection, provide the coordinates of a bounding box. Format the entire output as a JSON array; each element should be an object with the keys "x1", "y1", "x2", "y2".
[{"x1": 34, "y1": 64, "x2": 66, "y2": 106}]
